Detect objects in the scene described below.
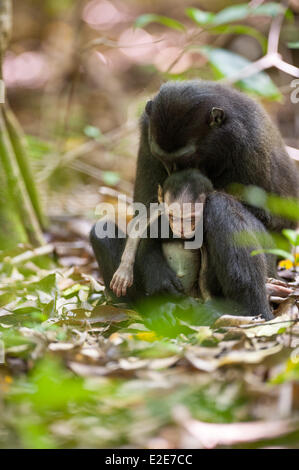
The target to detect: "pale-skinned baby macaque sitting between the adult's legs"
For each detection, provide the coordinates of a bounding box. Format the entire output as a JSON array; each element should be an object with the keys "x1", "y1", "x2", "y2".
[{"x1": 110, "y1": 169, "x2": 213, "y2": 297}]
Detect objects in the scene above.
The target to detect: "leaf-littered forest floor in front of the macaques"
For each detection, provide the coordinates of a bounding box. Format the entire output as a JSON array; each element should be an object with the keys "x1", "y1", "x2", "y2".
[{"x1": 0, "y1": 220, "x2": 299, "y2": 449}]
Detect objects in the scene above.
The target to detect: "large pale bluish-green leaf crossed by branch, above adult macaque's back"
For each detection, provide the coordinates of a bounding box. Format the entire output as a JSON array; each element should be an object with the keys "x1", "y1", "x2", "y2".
[{"x1": 200, "y1": 46, "x2": 281, "y2": 100}]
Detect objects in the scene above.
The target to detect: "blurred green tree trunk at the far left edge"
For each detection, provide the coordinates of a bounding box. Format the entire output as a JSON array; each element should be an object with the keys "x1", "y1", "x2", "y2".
[{"x1": 0, "y1": 0, "x2": 43, "y2": 249}]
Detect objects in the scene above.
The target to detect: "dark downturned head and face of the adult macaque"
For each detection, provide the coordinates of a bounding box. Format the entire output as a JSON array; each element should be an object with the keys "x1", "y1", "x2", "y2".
[{"x1": 145, "y1": 87, "x2": 225, "y2": 174}]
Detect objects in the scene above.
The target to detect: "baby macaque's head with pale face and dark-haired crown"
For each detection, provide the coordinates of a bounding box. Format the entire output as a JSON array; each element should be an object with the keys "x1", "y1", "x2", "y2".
[{"x1": 158, "y1": 169, "x2": 213, "y2": 239}]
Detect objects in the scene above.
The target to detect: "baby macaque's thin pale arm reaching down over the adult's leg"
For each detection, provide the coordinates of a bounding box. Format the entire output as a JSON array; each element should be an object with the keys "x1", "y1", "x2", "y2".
[{"x1": 110, "y1": 210, "x2": 161, "y2": 297}]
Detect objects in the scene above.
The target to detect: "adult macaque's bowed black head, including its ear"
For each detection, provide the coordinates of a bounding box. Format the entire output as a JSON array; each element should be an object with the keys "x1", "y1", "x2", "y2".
[{"x1": 145, "y1": 81, "x2": 227, "y2": 174}]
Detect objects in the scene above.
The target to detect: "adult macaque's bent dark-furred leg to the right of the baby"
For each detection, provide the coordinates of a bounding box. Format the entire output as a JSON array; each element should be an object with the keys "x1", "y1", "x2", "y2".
[{"x1": 203, "y1": 192, "x2": 275, "y2": 320}]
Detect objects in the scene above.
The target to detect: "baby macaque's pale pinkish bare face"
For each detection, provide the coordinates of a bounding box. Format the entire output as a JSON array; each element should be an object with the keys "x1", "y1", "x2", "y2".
[{"x1": 158, "y1": 187, "x2": 206, "y2": 239}]
